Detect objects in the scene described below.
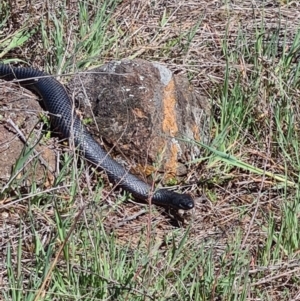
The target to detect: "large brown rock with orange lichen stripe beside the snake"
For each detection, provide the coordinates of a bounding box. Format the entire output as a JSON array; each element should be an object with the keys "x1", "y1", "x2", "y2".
[{"x1": 68, "y1": 59, "x2": 208, "y2": 180}]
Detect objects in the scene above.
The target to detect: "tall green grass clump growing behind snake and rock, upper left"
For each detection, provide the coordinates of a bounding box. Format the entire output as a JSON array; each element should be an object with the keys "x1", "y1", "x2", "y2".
[{"x1": 41, "y1": 0, "x2": 120, "y2": 73}]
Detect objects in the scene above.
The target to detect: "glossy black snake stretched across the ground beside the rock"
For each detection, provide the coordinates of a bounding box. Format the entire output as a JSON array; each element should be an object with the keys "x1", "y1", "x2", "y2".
[{"x1": 0, "y1": 64, "x2": 194, "y2": 210}]
